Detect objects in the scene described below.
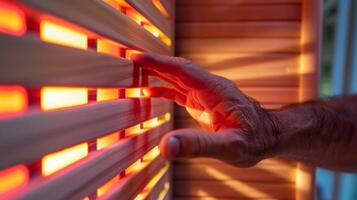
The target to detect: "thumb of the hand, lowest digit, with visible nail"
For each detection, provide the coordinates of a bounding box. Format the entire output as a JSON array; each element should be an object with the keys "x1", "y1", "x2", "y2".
[{"x1": 160, "y1": 129, "x2": 227, "y2": 160}]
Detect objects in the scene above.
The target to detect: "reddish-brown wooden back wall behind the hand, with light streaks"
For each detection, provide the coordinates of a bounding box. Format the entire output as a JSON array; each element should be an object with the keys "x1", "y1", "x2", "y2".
[{"x1": 174, "y1": 0, "x2": 321, "y2": 200}]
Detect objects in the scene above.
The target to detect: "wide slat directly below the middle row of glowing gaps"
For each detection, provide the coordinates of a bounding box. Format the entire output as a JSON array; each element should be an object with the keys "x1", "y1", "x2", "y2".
[{"x1": 0, "y1": 99, "x2": 171, "y2": 168}]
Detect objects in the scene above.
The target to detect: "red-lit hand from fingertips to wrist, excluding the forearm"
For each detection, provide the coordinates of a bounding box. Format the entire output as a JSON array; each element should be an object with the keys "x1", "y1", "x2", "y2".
[{"x1": 132, "y1": 54, "x2": 278, "y2": 167}]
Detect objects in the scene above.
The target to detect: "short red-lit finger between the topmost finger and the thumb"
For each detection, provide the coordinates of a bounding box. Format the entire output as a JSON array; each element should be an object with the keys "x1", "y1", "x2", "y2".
[{"x1": 145, "y1": 86, "x2": 186, "y2": 106}]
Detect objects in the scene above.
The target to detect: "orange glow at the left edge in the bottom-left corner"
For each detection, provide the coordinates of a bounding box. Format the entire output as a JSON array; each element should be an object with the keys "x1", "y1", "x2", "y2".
[{"x1": 0, "y1": 165, "x2": 29, "y2": 195}]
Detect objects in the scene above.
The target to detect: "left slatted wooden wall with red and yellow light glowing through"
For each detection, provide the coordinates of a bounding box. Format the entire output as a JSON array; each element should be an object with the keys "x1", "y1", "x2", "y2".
[{"x1": 0, "y1": 0, "x2": 174, "y2": 200}]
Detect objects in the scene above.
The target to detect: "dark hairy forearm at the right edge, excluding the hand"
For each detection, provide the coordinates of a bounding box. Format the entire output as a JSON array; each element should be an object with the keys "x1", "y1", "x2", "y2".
[{"x1": 272, "y1": 96, "x2": 357, "y2": 171}]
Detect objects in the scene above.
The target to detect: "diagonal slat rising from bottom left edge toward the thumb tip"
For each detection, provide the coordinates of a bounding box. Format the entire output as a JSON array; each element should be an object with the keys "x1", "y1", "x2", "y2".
[{"x1": 7, "y1": 124, "x2": 170, "y2": 200}]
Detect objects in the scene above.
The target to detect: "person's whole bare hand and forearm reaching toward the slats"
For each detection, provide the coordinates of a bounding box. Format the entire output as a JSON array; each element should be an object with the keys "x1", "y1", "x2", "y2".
[{"x1": 132, "y1": 54, "x2": 357, "y2": 172}]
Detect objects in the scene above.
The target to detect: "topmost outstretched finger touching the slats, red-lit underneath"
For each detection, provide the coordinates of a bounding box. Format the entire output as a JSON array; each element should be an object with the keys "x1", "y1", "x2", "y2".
[{"x1": 131, "y1": 53, "x2": 212, "y2": 89}]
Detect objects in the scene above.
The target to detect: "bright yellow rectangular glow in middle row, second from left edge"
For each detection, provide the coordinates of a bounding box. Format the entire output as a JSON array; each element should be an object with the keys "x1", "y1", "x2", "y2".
[{"x1": 41, "y1": 87, "x2": 88, "y2": 110}]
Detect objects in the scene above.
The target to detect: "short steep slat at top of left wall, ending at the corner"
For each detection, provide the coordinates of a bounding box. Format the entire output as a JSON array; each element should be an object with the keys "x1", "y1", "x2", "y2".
[{"x1": 126, "y1": 0, "x2": 173, "y2": 38}]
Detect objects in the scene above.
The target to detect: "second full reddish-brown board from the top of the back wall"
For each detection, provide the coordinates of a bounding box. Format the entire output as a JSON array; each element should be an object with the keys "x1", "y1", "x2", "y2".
[{"x1": 176, "y1": 22, "x2": 300, "y2": 38}]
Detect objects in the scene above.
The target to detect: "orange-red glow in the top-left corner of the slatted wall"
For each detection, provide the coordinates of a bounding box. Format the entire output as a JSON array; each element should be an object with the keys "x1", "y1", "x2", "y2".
[{"x1": 0, "y1": 2, "x2": 26, "y2": 36}]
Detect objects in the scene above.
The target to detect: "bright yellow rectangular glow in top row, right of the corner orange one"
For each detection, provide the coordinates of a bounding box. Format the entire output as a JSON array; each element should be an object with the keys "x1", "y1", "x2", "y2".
[{"x1": 40, "y1": 20, "x2": 88, "y2": 49}]
